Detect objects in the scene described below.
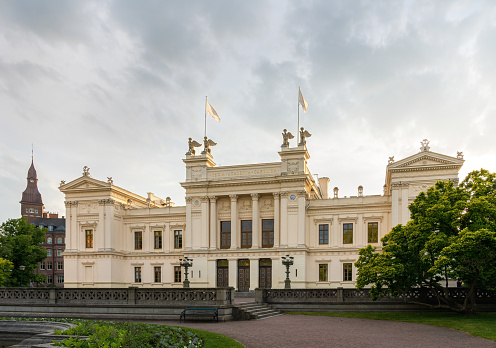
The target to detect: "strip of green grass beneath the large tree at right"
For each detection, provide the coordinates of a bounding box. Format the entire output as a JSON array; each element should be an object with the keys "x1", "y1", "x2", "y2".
[{"x1": 286, "y1": 312, "x2": 496, "y2": 341}]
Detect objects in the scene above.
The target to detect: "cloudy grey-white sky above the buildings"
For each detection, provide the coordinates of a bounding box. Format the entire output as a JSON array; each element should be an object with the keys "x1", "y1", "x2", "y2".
[{"x1": 0, "y1": 0, "x2": 496, "y2": 221}]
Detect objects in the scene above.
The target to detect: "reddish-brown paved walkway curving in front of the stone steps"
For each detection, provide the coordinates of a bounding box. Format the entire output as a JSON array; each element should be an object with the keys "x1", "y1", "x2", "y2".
[{"x1": 160, "y1": 314, "x2": 496, "y2": 348}]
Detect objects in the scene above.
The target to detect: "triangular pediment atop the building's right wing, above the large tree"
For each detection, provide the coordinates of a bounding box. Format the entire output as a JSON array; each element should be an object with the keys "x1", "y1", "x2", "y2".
[{"x1": 388, "y1": 151, "x2": 464, "y2": 171}]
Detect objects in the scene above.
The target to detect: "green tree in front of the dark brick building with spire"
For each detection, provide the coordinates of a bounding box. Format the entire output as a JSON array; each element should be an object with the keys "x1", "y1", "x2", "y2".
[{"x1": 0, "y1": 218, "x2": 47, "y2": 286}]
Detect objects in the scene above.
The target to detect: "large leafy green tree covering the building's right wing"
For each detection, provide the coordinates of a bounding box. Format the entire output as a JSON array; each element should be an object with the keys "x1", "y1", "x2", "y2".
[{"x1": 356, "y1": 169, "x2": 496, "y2": 313}]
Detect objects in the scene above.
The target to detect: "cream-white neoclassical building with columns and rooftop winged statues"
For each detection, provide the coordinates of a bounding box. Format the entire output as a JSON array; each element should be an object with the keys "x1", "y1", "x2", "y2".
[{"x1": 60, "y1": 139, "x2": 464, "y2": 291}]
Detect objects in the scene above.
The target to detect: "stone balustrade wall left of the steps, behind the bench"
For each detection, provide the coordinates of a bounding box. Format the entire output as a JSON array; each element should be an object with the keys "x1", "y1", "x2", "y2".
[{"x1": 0, "y1": 288, "x2": 234, "y2": 321}]
